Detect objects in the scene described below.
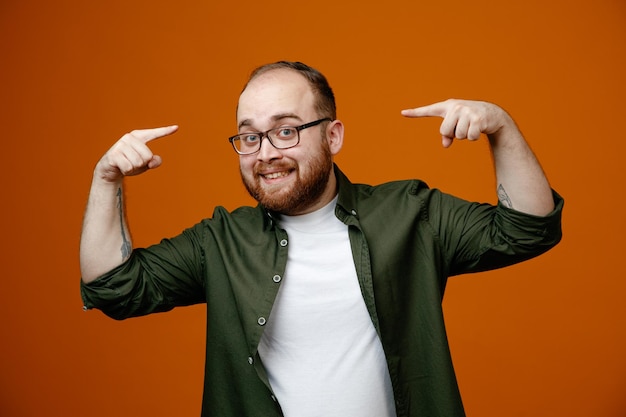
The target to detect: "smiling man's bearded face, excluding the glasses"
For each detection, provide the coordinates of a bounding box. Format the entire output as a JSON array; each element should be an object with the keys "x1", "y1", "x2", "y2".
[{"x1": 237, "y1": 69, "x2": 336, "y2": 215}]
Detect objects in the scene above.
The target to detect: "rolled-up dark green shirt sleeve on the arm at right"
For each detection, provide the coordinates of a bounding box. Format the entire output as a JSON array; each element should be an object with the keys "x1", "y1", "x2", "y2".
[{"x1": 429, "y1": 191, "x2": 564, "y2": 275}]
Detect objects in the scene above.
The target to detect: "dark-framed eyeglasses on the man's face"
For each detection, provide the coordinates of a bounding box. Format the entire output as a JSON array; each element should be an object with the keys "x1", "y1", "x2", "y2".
[{"x1": 228, "y1": 117, "x2": 332, "y2": 155}]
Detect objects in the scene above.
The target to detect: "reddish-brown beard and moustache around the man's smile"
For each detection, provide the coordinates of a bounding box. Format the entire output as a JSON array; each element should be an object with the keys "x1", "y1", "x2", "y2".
[{"x1": 240, "y1": 140, "x2": 333, "y2": 215}]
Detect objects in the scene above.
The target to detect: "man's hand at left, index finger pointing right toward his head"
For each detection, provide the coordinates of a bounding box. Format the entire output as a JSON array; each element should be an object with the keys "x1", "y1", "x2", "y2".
[{"x1": 94, "y1": 125, "x2": 178, "y2": 182}]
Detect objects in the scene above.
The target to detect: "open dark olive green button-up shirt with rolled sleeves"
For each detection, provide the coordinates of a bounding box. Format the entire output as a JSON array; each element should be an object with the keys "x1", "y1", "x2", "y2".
[{"x1": 81, "y1": 167, "x2": 563, "y2": 417}]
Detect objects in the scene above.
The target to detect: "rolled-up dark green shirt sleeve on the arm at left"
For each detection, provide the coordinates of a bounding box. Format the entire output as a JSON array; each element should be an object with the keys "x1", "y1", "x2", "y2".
[{"x1": 81, "y1": 223, "x2": 205, "y2": 320}]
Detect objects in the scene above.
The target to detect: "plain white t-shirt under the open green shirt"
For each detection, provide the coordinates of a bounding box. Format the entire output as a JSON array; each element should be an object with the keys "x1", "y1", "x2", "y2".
[{"x1": 259, "y1": 199, "x2": 395, "y2": 417}]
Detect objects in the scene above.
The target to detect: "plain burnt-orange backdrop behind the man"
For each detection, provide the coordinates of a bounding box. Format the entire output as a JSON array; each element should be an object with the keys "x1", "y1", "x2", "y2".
[{"x1": 0, "y1": 0, "x2": 626, "y2": 417}]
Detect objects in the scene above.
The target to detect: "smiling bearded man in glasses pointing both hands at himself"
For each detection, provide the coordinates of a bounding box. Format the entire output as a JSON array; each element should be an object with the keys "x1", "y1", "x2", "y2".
[{"x1": 80, "y1": 62, "x2": 563, "y2": 417}]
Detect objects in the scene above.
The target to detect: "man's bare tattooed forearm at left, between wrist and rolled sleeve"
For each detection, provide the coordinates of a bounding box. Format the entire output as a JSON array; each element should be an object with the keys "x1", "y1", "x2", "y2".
[{"x1": 80, "y1": 178, "x2": 132, "y2": 282}]
